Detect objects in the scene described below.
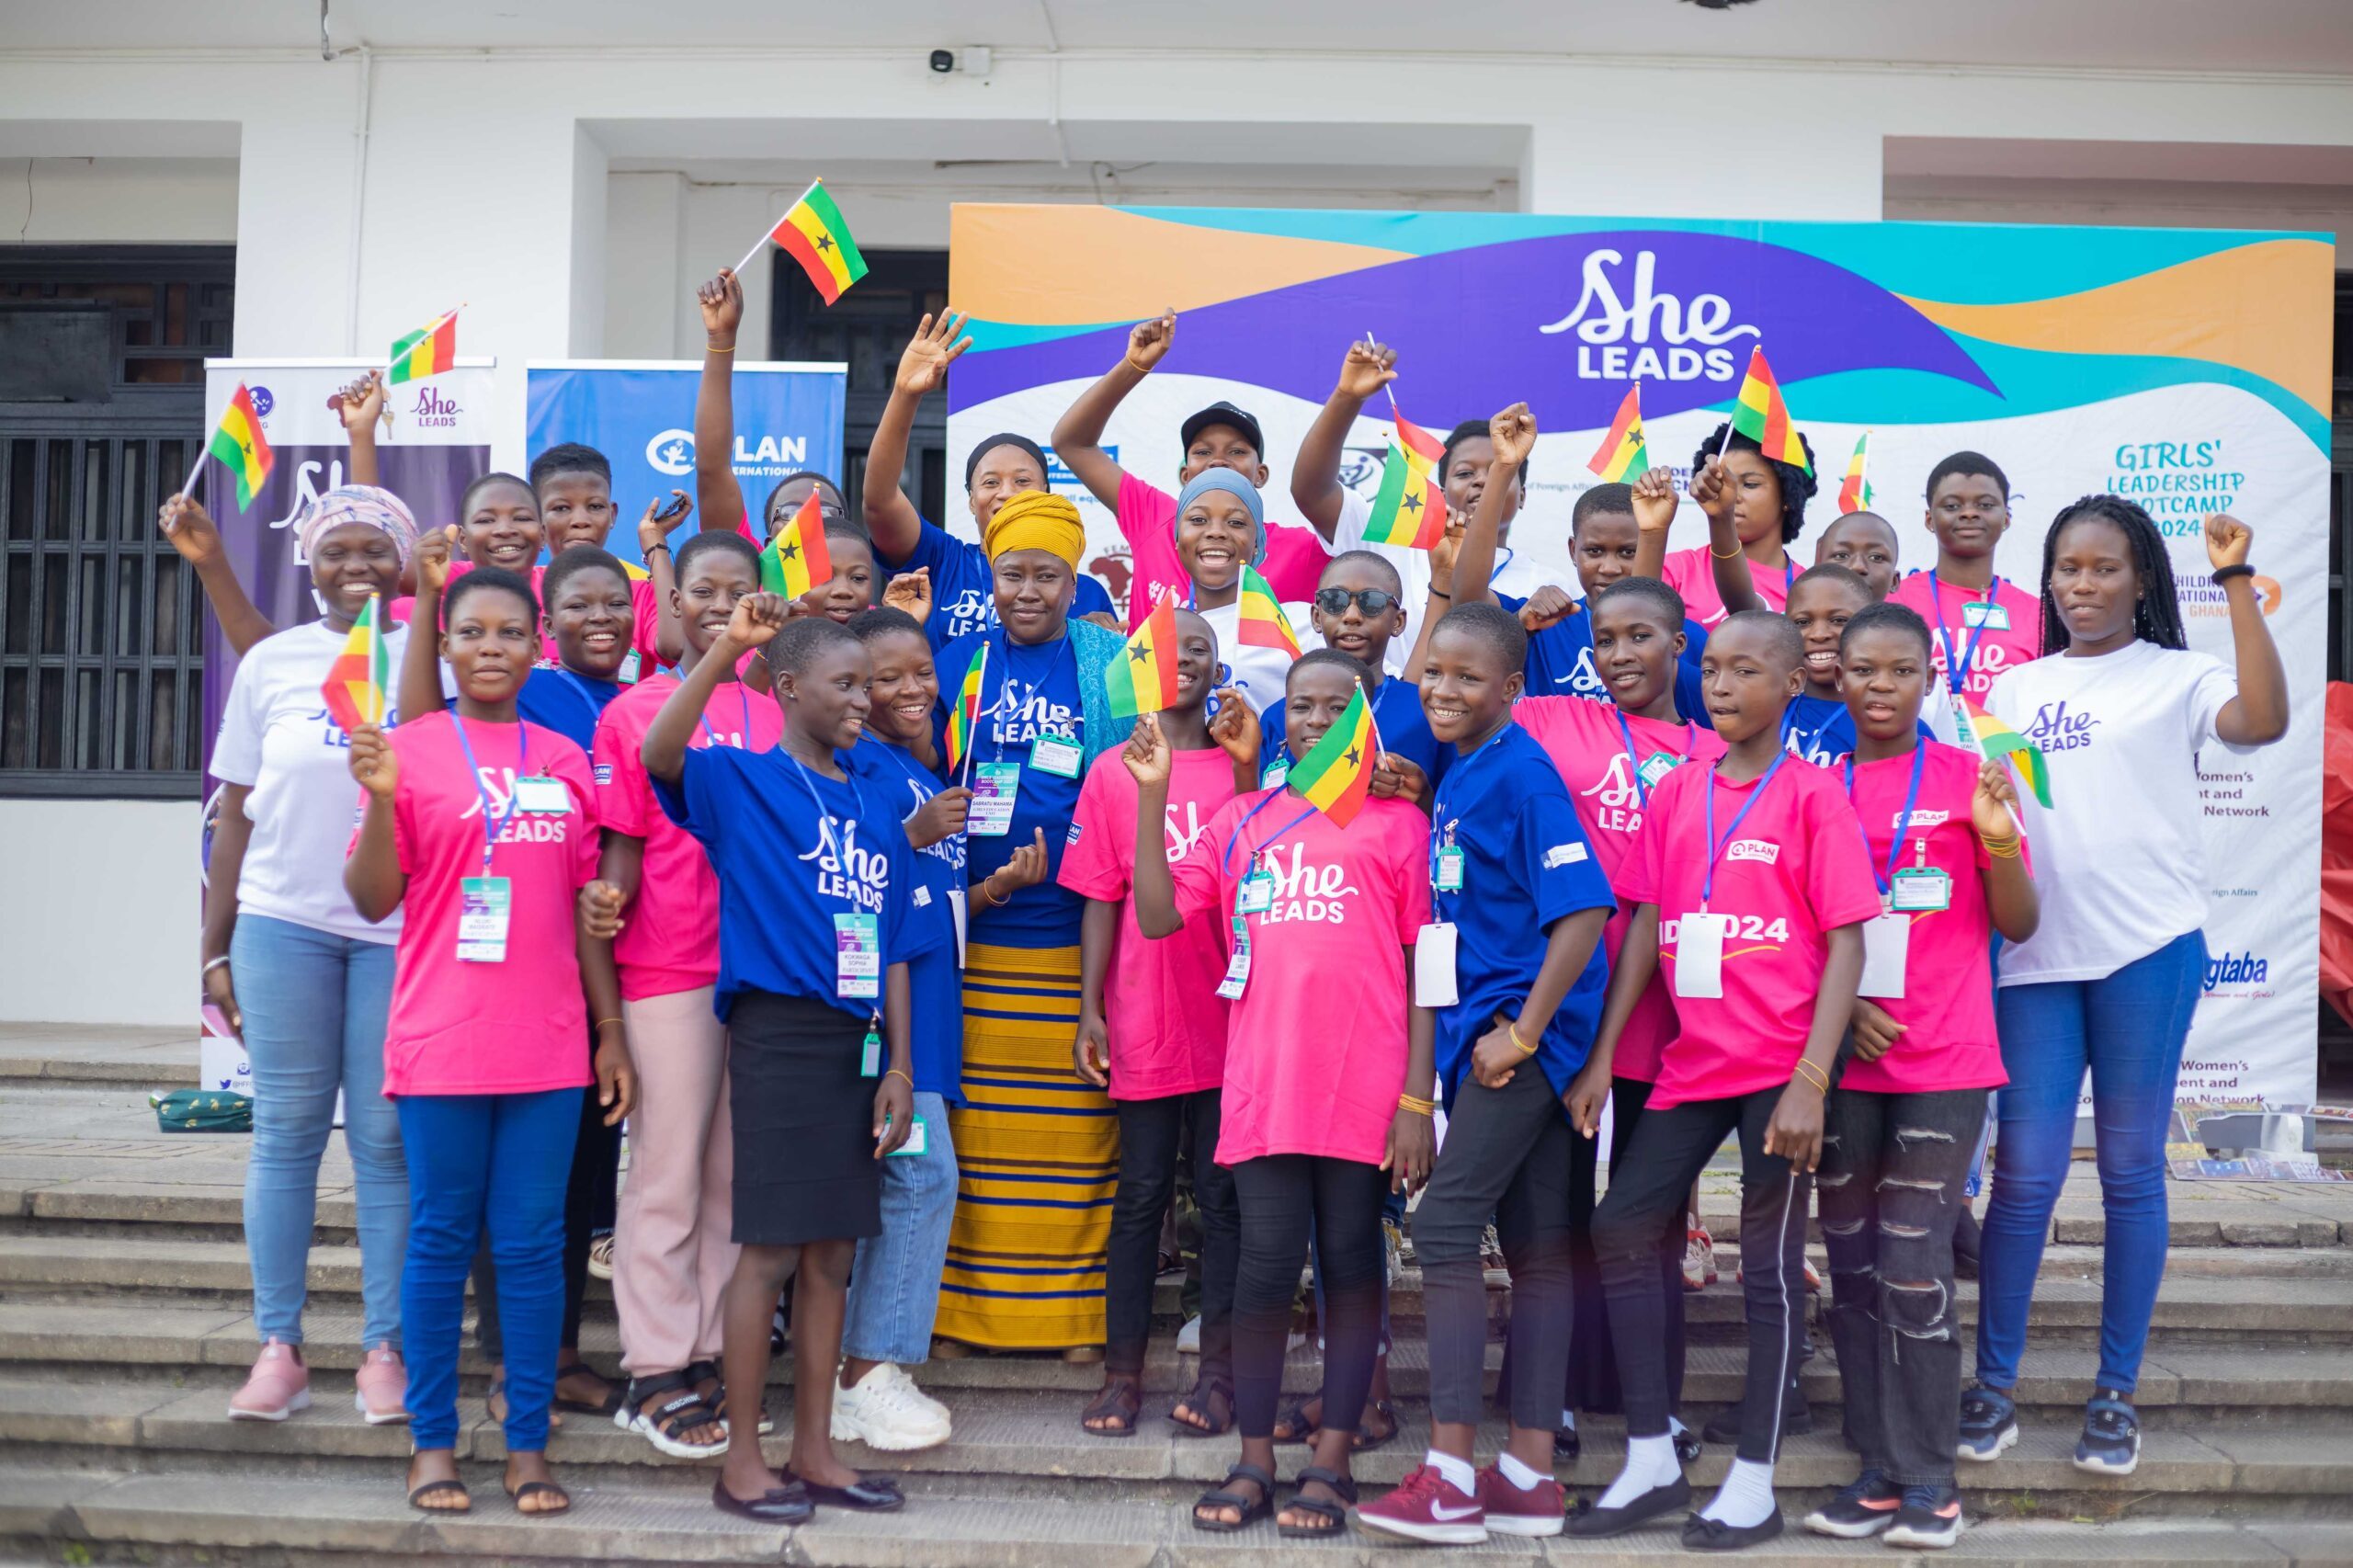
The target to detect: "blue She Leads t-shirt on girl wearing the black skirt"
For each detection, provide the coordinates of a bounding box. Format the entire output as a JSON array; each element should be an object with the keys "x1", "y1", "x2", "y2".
[{"x1": 654, "y1": 746, "x2": 953, "y2": 1019}]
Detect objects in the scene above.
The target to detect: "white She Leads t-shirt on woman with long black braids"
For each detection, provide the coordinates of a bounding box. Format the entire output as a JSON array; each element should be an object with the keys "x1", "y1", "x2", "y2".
[{"x1": 1986, "y1": 642, "x2": 2247, "y2": 986}]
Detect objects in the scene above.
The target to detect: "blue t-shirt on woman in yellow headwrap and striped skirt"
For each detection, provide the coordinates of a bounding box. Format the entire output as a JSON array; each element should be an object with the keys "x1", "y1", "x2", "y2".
[{"x1": 932, "y1": 631, "x2": 1087, "y2": 947}]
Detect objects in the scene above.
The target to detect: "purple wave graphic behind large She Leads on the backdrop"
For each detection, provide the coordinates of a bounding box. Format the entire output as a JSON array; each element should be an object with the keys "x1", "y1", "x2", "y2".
[{"x1": 949, "y1": 228, "x2": 2000, "y2": 431}]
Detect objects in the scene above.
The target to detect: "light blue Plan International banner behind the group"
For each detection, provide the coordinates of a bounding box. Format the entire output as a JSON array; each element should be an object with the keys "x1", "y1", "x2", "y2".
[{"x1": 525, "y1": 360, "x2": 849, "y2": 565}]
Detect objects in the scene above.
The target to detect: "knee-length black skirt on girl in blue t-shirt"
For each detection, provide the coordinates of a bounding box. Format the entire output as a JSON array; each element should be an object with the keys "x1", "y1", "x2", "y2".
[{"x1": 727, "y1": 991, "x2": 882, "y2": 1248}]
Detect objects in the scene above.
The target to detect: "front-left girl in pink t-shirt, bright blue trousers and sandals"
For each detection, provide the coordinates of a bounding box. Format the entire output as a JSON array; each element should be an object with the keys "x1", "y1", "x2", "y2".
[{"x1": 344, "y1": 567, "x2": 635, "y2": 1514}]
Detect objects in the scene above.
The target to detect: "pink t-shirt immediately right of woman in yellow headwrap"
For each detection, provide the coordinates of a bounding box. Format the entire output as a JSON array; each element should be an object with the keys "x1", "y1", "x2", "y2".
[{"x1": 1062, "y1": 746, "x2": 1233, "y2": 1099}]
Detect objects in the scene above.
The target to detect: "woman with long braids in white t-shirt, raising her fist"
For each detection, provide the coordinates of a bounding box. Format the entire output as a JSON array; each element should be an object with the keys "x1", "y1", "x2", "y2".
[{"x1": 1960, "y1": 494, "x2": 2287, "y2": 1476}]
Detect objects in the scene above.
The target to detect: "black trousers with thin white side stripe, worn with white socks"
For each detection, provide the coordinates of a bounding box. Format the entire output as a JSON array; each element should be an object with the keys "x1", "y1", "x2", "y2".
[{"x1": 1593, "y1": 1085, "x2": 1810, "y2": 1464}]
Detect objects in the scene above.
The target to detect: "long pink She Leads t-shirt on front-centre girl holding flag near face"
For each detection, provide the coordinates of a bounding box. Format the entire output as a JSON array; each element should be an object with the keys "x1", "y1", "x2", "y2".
[{"x1": 1172, "y1": 789, "x2": 1430, "y2": 1165}]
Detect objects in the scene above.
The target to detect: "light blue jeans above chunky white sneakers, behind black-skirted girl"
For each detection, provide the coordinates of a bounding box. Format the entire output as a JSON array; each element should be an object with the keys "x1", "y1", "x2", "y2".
[{"x1": 842, "y1": 1095, "x2": 955, "y2": 1366}]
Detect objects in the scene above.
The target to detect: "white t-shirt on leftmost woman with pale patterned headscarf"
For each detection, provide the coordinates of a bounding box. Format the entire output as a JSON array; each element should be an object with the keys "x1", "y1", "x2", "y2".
[{"x1": 211, "y1": 621, "x2": 409, "y2": 942}]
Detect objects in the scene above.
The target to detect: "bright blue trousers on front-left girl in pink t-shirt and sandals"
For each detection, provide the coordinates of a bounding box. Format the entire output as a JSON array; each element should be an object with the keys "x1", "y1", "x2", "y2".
[{"x1": 398, "y1": 1087, "x2": 581, "y2": 1452}]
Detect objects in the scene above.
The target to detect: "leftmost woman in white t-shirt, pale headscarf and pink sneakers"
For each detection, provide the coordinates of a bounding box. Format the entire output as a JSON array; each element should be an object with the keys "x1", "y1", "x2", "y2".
[{"x1": 188, "y1": 485, "x2": 416, "y2": 1425}]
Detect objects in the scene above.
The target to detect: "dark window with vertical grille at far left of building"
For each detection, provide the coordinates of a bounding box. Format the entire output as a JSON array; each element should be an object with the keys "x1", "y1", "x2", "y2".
[{"x1": 0, "y1": 247, "x2": 235, "y2": 798}]
